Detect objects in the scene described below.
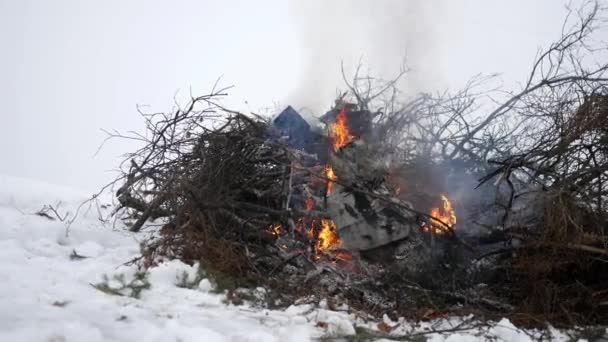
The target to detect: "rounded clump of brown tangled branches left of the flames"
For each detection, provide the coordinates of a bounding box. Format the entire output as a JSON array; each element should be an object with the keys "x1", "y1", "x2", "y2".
[{"x1": 107, "y1": 93, "x2": 308, "y2": 275}]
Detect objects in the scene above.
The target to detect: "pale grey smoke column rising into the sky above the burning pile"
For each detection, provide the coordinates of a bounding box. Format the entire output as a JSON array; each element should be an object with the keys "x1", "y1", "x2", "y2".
[{"x1": 287, "y1": 0, "x2": 443, "y2": 113}]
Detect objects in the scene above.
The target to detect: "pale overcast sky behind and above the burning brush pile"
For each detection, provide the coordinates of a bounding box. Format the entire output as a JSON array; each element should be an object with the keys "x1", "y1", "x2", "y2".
[{"x1": 0, "y1": 0, "x2": 584, "y2": 191}]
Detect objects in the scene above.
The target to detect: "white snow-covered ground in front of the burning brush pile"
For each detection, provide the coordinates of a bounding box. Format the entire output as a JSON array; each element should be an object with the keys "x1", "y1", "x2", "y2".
[{"x1": 0, "y1": 175, "x2": 592, "y2": 342}]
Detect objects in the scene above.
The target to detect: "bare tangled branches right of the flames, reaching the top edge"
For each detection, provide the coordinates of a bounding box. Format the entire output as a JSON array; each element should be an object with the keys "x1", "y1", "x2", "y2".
[{"x1": 332, "y1": 1, "x2": 608, "y2": 325}]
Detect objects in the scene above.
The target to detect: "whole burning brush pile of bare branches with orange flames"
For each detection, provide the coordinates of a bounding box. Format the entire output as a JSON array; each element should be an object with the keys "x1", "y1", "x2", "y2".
[{"x1": 105, "y1": 4, "x2": 608, "y2": 326}]
